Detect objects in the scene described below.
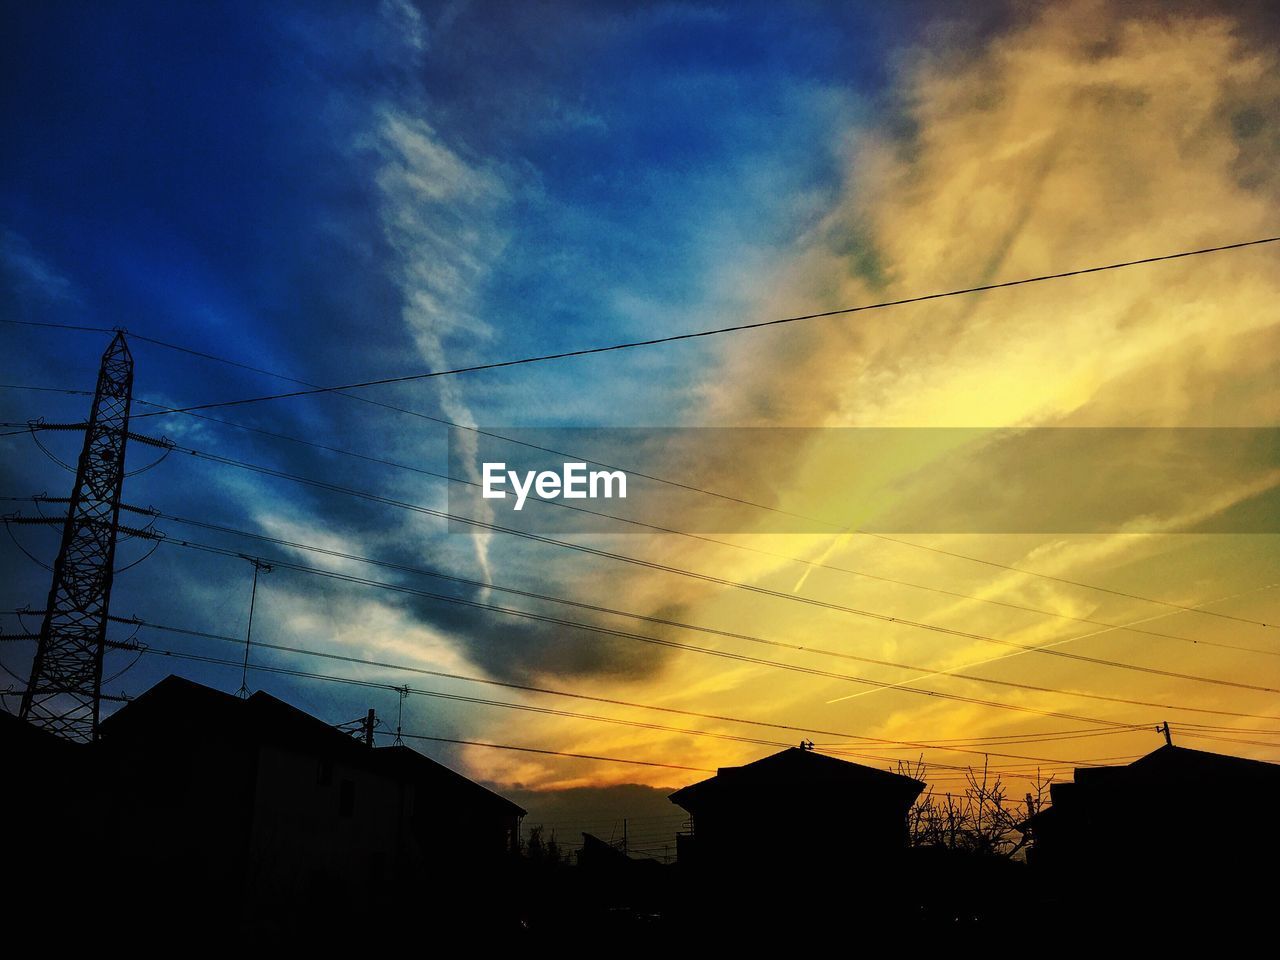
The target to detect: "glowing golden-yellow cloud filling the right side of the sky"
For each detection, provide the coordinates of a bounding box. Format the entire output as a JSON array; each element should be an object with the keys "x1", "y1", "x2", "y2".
[{"x1": 450, "y1": 3, "x2": 1280, "y2": 786}]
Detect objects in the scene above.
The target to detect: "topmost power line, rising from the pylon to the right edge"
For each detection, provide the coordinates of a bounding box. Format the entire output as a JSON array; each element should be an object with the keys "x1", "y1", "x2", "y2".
[{"x1": 110, "y1": 237, "x2": 1280, "y2": 417}]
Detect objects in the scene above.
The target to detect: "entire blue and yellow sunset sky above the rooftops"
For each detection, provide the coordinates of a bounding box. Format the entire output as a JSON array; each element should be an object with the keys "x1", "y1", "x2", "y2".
[{"x1": 0, "y1": 0, "x2": 1280, "y2": 849}]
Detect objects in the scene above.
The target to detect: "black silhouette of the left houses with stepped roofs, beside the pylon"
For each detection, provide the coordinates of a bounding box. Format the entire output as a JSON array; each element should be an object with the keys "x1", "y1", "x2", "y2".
[{"x1": 96, "y1": 676, "x2": 525, "y2": 919}]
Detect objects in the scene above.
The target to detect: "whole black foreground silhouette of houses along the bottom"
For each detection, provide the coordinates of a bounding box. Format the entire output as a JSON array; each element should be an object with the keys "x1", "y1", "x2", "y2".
[{"x1": 0, "y1": 677, "x2": 1280, "y2": 950}]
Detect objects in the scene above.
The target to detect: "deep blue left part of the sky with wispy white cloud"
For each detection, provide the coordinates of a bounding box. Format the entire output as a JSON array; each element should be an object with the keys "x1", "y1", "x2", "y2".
[{"x1": 0, "y1": 3, "x2": 910, "y2": 757}]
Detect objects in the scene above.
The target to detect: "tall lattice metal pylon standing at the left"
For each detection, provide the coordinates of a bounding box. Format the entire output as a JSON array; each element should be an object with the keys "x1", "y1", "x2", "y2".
[{"x1": 20, "y1": 333, "x2": 133, "y2": 741}]
